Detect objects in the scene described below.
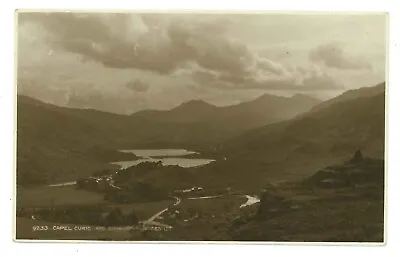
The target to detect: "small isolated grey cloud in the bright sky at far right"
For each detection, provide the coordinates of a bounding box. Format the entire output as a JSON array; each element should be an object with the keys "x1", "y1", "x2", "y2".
[{"x1": 309, "y1": 43, "x2": 372, "y2": 70}]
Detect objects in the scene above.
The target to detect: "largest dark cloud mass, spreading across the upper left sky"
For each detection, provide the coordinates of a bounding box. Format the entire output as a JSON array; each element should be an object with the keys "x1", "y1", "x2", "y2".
[{"x1": 20, "y1": 13, "x2": 251, "y2": 74}]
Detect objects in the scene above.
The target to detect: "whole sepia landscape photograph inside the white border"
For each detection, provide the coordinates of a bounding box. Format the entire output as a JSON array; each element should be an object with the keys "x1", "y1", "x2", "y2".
[{"x1": 14, "y1": 9, "x2": 389, "y2": 242}]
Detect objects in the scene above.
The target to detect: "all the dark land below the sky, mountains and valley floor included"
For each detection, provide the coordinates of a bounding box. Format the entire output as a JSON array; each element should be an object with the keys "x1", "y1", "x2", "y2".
[{"x1": 16, "y1": 81, "x2": 385, "y2": 242}]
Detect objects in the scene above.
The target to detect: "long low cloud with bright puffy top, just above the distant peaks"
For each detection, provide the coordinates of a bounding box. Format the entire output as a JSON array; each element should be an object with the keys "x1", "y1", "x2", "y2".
[{"x1": 176, "y1": 56, "x2": 343, "y2": 91}]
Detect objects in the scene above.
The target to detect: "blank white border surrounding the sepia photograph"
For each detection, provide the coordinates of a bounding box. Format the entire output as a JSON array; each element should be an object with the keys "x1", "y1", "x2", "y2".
[{"x1": 0, "y1": 0, "x2": 400, "y2": 256}]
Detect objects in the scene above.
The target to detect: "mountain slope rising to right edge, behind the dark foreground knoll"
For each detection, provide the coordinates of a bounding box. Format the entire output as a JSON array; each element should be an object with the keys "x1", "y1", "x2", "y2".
[{"x1": 226, "y1": 84, "x2": 385, "y2": 161}]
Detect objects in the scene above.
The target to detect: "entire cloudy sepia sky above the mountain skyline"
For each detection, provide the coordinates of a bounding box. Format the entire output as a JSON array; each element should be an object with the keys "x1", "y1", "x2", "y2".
[{"x1": 17, "y1": 12, "x2": 386, "y2": 114}]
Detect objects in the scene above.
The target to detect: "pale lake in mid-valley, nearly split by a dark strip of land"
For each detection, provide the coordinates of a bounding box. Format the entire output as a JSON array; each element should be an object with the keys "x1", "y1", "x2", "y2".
[{"x1": 113, "y1": 149, "x2": 214, "y2": 169}]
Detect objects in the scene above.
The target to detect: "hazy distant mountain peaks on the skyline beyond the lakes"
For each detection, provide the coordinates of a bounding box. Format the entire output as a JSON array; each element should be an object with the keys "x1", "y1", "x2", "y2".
[{"x1": 131, "y1": 91, "x2": 320, "y2": 130}]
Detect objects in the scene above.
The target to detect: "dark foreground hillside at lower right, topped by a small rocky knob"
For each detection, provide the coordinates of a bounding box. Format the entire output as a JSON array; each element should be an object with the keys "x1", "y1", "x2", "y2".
[{"x1": 229, "y1": 152, "x2": 385, "y2": 242}]
